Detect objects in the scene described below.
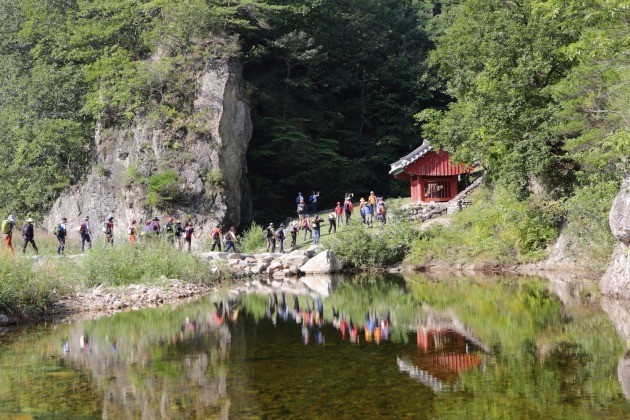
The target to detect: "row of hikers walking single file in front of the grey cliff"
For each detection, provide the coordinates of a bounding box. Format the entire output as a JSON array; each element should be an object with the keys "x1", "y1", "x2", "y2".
[{"x1": 2, "y1": 215, "x2": 237, "y2": 255}]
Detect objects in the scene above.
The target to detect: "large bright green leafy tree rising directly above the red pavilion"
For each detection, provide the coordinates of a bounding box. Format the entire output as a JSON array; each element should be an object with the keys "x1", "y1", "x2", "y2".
[{"x1": 417, "y1": 0, "x2": 583, "y2": 197}]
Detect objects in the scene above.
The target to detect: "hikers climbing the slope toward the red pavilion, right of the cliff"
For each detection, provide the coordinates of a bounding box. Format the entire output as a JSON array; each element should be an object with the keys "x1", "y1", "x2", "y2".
[{"x1": 263, "y1": 191, "x2": 387, "y2": 252}]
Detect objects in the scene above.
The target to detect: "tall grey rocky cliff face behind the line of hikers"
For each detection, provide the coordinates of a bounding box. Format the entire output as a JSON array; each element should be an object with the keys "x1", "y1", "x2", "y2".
[{"x1": 44, "y1": 61, "x2": 252, "y2": 249}]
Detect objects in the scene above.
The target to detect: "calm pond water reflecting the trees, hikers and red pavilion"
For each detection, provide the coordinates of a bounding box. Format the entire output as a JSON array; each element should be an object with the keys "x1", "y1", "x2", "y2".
[{"x1": 0, "y1": 276, "x2": 630, "y2": 419}]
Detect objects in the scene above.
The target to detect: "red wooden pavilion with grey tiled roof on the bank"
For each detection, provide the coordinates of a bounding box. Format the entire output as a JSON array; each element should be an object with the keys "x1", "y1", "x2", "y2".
[{"x1": 389, "y1": 140, "x2": 473, "y2": 203}]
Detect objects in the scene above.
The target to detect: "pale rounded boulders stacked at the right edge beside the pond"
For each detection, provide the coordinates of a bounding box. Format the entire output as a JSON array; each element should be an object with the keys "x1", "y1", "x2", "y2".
[{"x1": 600, "y1": 175, "x2": 630, "y2": 299}]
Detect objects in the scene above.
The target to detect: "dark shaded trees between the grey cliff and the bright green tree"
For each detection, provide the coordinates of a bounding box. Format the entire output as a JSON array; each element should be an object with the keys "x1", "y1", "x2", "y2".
[{"x1": 243, "y1": 0, "x2": 444, "y2": 221}]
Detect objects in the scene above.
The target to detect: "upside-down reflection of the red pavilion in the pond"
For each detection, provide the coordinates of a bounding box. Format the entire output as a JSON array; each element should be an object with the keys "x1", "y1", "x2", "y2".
[{"x1": 398, "y1": 326, "x2": 484, "y2": 391}]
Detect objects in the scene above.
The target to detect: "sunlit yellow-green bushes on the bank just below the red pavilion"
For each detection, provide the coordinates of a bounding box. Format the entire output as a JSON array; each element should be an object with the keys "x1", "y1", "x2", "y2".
[{"x1": 409, "y1": 188, "x2": 559, "y2": 264}]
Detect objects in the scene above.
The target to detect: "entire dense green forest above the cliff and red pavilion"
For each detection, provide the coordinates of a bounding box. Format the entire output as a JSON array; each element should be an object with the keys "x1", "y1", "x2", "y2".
[{"x1": 0, "y1": 0, "x2": 630, "y2": 253}]
